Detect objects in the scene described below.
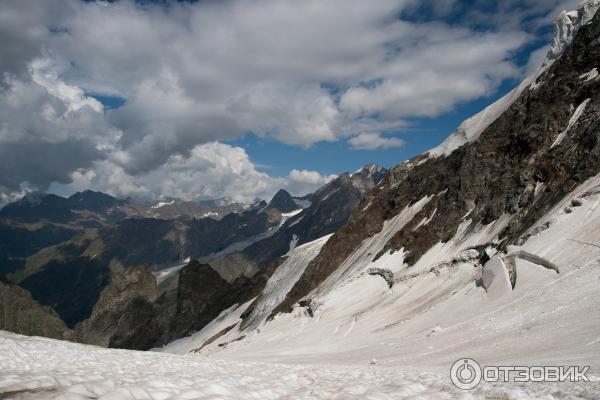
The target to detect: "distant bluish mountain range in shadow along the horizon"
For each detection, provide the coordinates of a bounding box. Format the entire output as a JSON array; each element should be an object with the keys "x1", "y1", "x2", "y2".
[{"x1": 0, "y1": 165, "x2": 385, "y2": 328}]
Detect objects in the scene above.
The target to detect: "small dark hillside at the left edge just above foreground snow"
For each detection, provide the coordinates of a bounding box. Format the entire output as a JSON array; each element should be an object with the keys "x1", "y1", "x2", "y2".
[{"x1": 0, "y1": 281, "x2": 71, "y2": 339}]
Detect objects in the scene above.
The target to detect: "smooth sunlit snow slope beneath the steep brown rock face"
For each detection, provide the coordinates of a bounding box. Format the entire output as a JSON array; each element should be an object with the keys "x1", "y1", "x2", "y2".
[{"x1": 154, "y1": 175, "x2": 600, "y2": 399}]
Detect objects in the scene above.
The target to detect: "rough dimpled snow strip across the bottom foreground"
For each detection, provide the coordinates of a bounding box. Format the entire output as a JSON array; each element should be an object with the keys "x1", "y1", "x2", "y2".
[{"x1": 0, "y1": 331, "x2": 600, "y2": 400}]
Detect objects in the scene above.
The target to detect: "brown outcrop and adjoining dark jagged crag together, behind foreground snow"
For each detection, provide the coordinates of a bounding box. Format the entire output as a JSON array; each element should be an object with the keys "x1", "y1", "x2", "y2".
[{"x1": 82, "y1": 260, "x2": 280, "y2": 350}]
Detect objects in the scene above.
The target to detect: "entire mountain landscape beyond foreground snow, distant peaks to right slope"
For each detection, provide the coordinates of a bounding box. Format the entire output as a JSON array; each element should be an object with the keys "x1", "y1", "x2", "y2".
[{"x1": 0, "y1": 0, "x2": 600, "y2": 398}]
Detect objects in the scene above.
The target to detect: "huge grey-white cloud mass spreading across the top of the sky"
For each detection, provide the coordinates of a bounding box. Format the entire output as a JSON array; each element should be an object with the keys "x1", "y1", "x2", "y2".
[{"x1": 43, "y1": 0, "x2": 528, "y2": 166}]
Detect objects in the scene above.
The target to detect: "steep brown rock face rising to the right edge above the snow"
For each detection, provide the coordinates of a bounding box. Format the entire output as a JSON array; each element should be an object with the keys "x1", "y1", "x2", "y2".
[{"x1": 276, "y1": 13, "x2": 600, "y2": 312}]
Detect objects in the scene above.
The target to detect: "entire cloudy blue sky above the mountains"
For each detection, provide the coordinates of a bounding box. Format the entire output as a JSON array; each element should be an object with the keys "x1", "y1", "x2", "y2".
[{"x1": 0, "y1": 0, "x2": 579, "y2": 205}]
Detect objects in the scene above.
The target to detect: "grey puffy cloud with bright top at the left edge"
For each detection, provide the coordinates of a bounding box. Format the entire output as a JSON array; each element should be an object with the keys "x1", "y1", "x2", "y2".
[{"x1": 0, "y1": 75, "x2": 118, "y2": 192}]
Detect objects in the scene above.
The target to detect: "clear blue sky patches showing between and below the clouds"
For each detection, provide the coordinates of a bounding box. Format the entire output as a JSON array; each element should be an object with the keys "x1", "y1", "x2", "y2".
[{"x1": 92, "y1": 0, "x2": 564, "y2": 176}]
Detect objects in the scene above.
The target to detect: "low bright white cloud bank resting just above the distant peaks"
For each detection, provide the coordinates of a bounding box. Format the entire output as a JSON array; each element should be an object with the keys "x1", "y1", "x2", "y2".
[{"x1": 54, "y1": 142, "x2": 335, "y2": 202}]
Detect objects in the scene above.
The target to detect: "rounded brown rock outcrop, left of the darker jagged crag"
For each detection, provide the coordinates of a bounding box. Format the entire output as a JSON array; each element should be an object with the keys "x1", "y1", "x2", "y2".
[{"x1": 74, "y1": 266, "x2": 158, "y2": 348}]
